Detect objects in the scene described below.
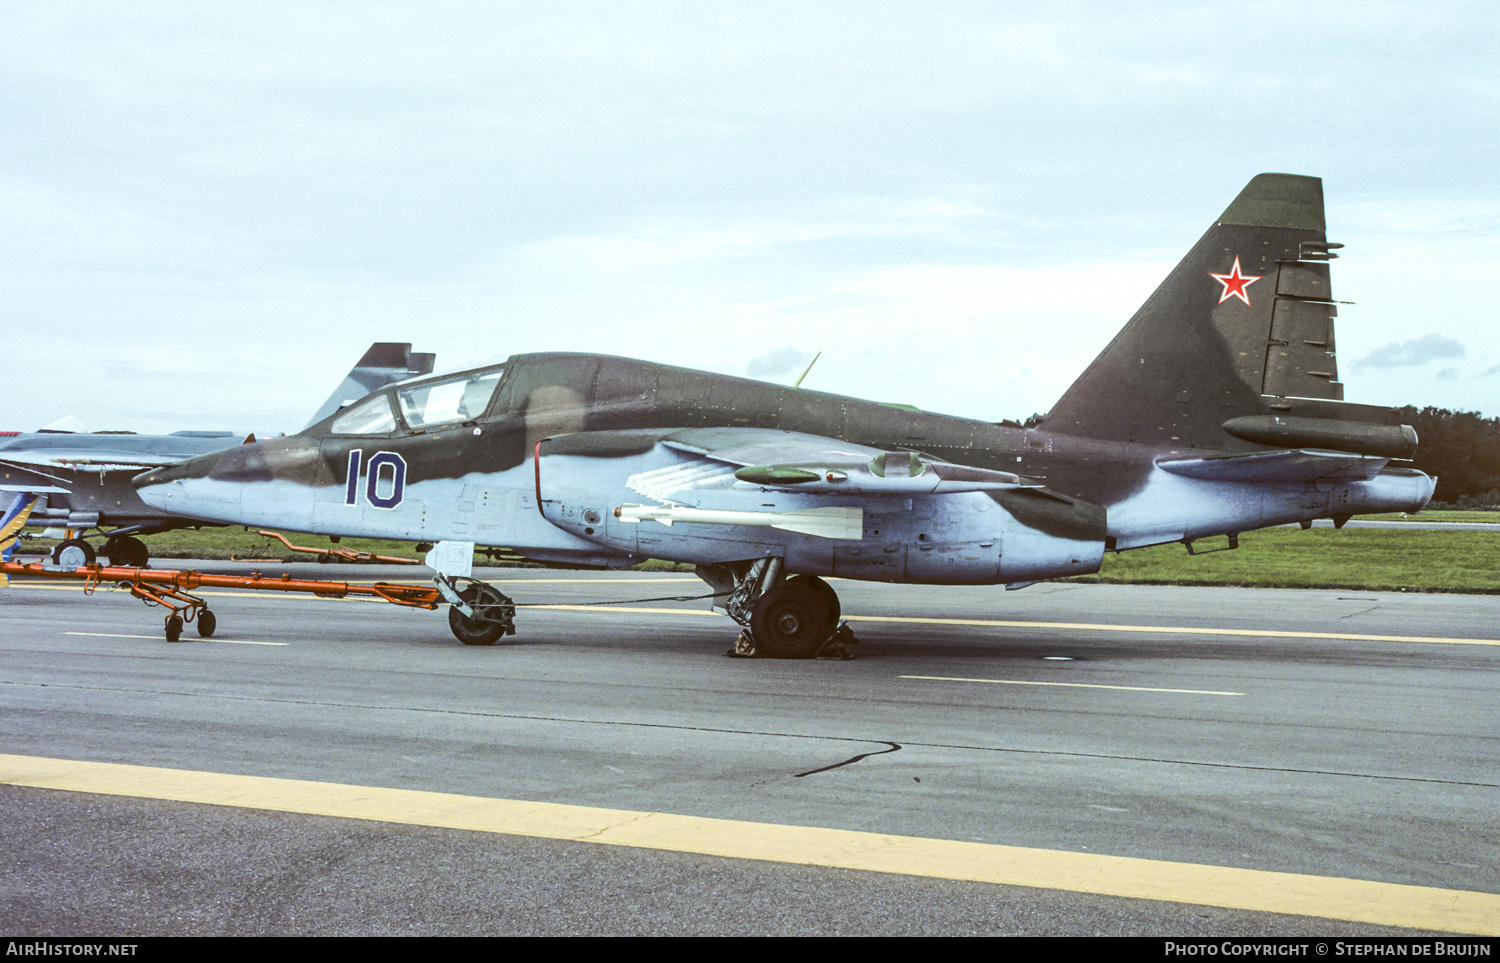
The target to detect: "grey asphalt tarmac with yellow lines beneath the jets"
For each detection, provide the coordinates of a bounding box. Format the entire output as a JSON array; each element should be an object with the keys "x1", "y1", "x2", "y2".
[{"x1": 0, "y1": 564, "x2": 1500, "y2": 936}]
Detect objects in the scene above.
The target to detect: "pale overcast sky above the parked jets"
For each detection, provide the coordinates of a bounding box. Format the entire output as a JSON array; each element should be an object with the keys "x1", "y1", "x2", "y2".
[{"x1": 0, "y1": 0, "x2": 1500, "y2": 432}]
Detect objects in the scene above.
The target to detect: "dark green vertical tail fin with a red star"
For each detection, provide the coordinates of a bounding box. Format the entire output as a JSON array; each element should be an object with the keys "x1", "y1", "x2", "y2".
[{"x1": 1041, "y1": 174, "x2": 1415, "y2": 458}]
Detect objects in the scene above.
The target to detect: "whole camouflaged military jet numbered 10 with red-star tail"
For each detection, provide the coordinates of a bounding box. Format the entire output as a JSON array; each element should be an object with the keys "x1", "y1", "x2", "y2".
[{"x1": 135, "y1": 174, "x2": 1434, "y2": 657}]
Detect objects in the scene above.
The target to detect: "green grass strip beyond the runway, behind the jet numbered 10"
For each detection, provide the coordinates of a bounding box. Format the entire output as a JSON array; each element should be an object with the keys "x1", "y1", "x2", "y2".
[{"x1": 21, "y1": 512, "x2": 1500, "y2": 594}]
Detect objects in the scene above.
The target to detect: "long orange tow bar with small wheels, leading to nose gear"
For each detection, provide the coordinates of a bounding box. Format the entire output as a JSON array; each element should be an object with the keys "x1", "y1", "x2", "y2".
[{"x1": 0, "y1": 563, "x2": 443, "y2": 642}]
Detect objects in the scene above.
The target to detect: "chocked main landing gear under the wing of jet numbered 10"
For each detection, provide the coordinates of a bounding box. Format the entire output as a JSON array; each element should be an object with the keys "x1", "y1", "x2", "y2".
[{"x1": 698, "y1": 558, "x2": 858, "y2": 659}]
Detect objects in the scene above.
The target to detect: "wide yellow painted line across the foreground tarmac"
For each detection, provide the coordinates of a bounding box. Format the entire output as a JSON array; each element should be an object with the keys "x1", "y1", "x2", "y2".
[{"x1": 0, "y1": 755, "x2": 1500, "y2": 935}]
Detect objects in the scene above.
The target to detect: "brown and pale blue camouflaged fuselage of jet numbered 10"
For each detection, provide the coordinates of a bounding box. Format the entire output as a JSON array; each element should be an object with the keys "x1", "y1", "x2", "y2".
[{"x1": 129, "y1": 354, "x2": 1431, "y2": 584}]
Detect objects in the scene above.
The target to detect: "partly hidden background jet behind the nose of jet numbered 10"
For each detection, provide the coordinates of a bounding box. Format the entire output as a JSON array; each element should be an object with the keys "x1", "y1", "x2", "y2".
[{"x1": 0, "y1": 342, "x2": 435, "y2": 569}]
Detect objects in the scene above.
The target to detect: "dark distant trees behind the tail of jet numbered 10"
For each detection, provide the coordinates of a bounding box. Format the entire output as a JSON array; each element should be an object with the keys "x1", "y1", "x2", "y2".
[{"x1": 1022, "y1": 405, "x2": 1500, "y2": 509}]
